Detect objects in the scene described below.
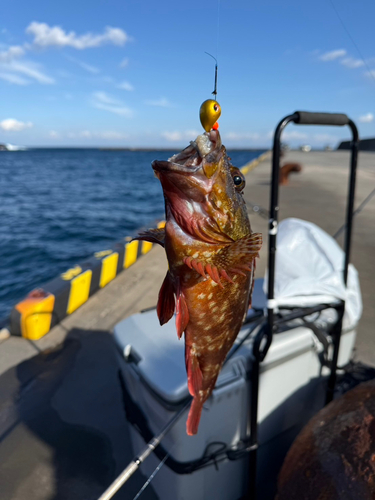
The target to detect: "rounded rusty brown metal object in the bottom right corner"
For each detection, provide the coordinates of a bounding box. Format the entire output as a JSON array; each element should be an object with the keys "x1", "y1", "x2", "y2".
[{"x1": 276, "y1": 380, "x2": 375, "y2": 500}]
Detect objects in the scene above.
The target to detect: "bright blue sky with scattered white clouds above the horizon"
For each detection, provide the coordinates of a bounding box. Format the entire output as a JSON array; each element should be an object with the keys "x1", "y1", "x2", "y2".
[{"x1": 0, "y1": 0, "x2": 375, "y2": 149}]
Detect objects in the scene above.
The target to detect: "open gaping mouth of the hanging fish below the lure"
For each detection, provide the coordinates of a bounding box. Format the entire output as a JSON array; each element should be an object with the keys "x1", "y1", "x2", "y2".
[{"x1": 152, "y1": 130, "x2": 222, "y2": 177}]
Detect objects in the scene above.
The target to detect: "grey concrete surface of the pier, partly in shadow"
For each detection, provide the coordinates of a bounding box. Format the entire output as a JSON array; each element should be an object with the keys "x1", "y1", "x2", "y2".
[{"x1": 0, "y1": 151, "x2": 375, "y2": 500}]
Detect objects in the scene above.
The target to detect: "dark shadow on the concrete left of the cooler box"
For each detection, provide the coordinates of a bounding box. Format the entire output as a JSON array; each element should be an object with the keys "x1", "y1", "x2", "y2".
[{"x1": 0, "y1": 329, "x2": 156, "y2": 500}]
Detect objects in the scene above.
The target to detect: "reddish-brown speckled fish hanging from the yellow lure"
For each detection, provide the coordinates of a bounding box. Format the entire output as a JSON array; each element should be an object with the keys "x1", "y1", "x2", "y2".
[{"x1": 136, "y1": 130, "x2": 262, "y2": 435}]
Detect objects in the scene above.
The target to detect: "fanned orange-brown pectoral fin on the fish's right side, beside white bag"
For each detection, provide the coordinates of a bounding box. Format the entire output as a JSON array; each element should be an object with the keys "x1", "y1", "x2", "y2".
[{"x1": 215, "y1": 233, "x2": 262, "y2": 275}]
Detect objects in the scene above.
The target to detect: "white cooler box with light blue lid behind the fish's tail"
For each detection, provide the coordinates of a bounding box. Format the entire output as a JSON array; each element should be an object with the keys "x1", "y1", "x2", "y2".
[{"x1": 114, "y1": 280, "x2": 358, "y2": 500}]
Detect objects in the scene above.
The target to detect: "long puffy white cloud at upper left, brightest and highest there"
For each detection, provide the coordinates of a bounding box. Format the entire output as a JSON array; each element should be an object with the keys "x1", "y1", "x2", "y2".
[{"x1": 26, "y1": 21, "x2": 129, "y2": 50}]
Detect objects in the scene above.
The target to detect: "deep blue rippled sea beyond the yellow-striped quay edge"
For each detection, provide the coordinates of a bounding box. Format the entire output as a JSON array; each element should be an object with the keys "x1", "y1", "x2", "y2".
[{"x1": 0, "y1": 149, "x2": 264, "y2": 319}]
